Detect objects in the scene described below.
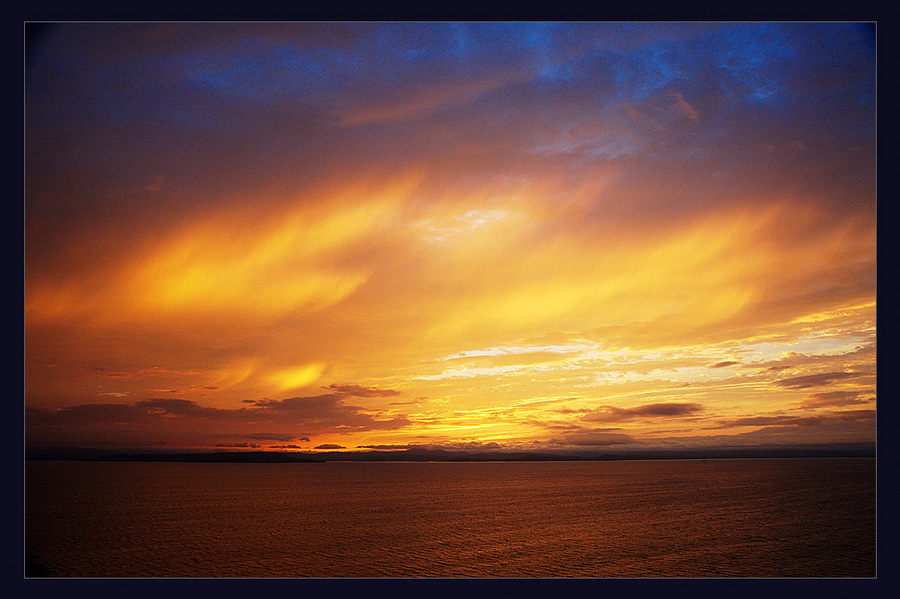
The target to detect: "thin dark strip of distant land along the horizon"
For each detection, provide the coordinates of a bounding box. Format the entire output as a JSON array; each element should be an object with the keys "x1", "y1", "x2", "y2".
[{"x1": 25, "y1": 445, "x2": 876, "y2": 463}]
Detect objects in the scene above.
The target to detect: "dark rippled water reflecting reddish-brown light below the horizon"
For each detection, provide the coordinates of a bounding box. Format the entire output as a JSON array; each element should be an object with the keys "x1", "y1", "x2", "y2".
[{"x1": 25, "y1": 458, "x2": 876, "y2": 578}]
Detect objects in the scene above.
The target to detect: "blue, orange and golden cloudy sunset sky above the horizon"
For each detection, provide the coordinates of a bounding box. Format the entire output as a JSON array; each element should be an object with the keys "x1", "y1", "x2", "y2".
[{"x1": 23, "y1": 22, "x2": 877, "y2": 451}]
